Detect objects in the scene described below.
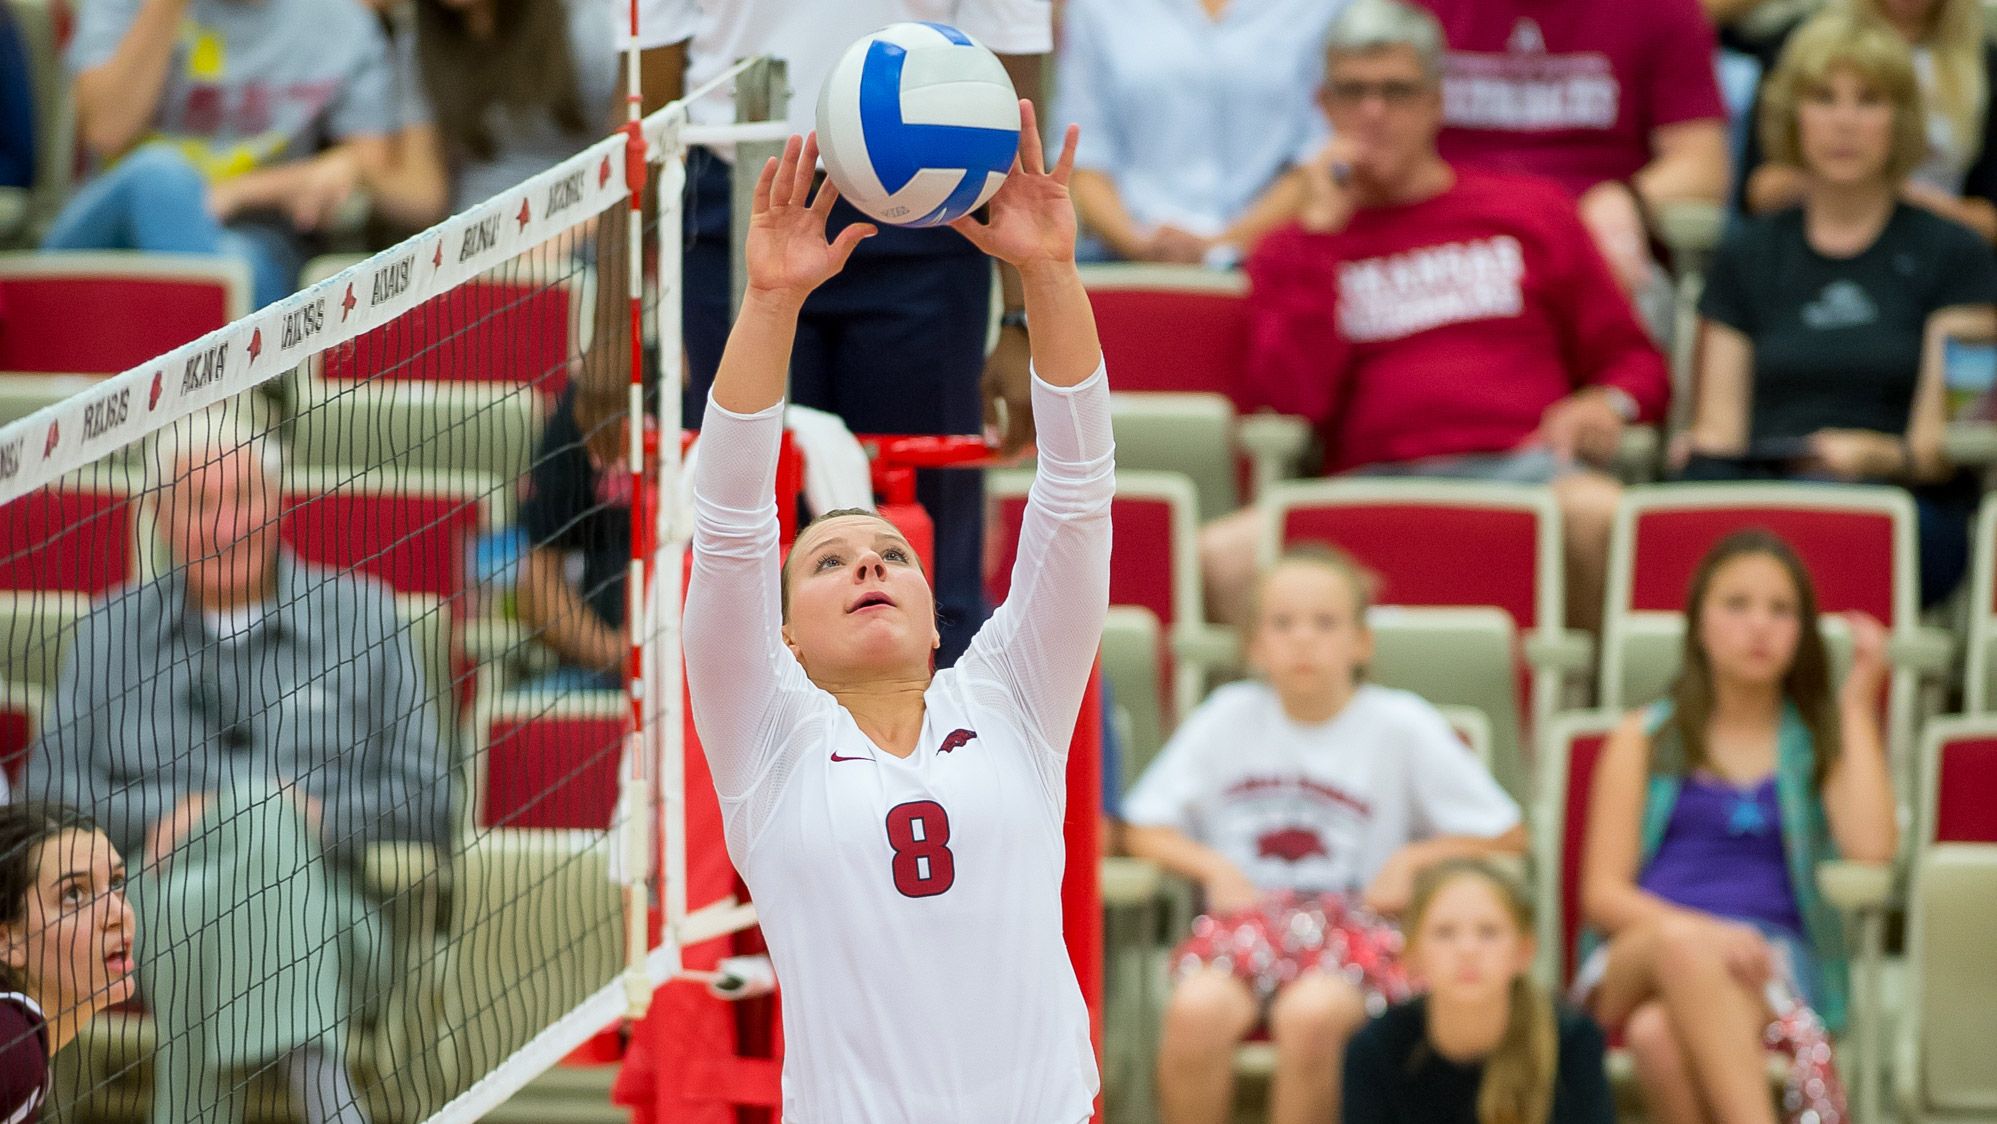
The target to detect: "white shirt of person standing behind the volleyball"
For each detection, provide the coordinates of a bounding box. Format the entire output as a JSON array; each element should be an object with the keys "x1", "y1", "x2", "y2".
[{"x1": 617, "y1": 0, "x2": 1054, "y2": 134}]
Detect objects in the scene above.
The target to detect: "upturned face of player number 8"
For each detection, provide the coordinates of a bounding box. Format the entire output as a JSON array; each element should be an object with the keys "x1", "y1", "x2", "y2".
[{"x1": 783, "y1": 515, "x2": 941, "y2": 683}]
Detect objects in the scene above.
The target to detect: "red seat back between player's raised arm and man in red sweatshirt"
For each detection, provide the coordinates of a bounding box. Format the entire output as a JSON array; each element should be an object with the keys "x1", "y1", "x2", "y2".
[{"x1": 1082, "y1": 266, "x2": 1248, "y2": 407}]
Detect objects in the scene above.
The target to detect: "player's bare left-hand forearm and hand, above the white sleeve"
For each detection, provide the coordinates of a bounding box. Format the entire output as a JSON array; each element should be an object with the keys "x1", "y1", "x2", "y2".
[{"x1": 713, "y1": 134, "x2": 875, "y2": 413}]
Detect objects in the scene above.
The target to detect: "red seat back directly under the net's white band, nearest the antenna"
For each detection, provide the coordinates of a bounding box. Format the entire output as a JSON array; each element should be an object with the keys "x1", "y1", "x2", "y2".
[{"x1": 320, "y1": 270, "x2": 589, "y2": 395}]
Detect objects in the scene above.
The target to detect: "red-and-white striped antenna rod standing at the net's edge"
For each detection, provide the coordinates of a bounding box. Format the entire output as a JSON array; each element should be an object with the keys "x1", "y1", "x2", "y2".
[{"x1": 615, "y1": 0, "x2": 655, "y2": 1018}]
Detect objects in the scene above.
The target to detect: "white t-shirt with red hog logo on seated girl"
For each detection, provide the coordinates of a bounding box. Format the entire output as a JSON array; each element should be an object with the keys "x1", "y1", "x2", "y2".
[{"x1": 1124, "y1": 683, "x2": 1520, "y2": 892}]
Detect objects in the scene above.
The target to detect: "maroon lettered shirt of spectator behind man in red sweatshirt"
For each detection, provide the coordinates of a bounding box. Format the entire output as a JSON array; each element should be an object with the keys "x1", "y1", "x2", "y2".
[{"x1": 1420, "y1": 0, "x2": 1727, "y2": 196}]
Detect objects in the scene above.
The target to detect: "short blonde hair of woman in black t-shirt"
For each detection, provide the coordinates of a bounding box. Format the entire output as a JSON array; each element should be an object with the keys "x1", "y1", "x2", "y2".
[{"x1": 1759, "y1": 10, "x2": 1927, "y2": 184}]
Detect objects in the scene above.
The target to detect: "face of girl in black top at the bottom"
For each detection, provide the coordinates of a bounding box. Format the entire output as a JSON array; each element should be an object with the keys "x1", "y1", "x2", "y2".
[{"x1": 1410, "y1": 876, "x2": 1534, "y2": 1006}]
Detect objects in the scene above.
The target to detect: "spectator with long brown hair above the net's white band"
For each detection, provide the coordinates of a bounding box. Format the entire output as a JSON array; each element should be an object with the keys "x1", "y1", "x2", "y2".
[{"x1": 415, "y1": 0, "x2": 623, "y2": 210}]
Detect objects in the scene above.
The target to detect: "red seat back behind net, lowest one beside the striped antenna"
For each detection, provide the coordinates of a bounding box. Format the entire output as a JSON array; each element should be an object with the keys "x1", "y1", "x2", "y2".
[{"x1": 469, "y1": 691, "x2": 631, "y2": 831}]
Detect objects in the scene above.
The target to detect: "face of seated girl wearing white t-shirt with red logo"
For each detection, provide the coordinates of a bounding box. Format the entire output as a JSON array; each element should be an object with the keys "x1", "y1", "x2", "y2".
[{"x1": 1248, "y1": 563, "x2": 1372, "y2": 699}]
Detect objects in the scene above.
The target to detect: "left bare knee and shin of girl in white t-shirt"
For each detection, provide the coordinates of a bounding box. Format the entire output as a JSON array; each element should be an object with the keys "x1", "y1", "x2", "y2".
[{"x1": 1158, "y1": 968, "x2": 1256, "y2": 1124}]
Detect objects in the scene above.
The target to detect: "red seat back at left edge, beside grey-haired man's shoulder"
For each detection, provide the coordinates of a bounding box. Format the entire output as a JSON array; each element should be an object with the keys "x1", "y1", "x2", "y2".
[{"x1": 0, "y1": 485, "x2": 132, "y2": 595}]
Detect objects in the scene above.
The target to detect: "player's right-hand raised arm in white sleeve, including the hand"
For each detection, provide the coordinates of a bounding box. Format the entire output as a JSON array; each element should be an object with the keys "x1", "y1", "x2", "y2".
[{"x1": 955, "y1": 102, "x2": 1116, "y2": 759}]
